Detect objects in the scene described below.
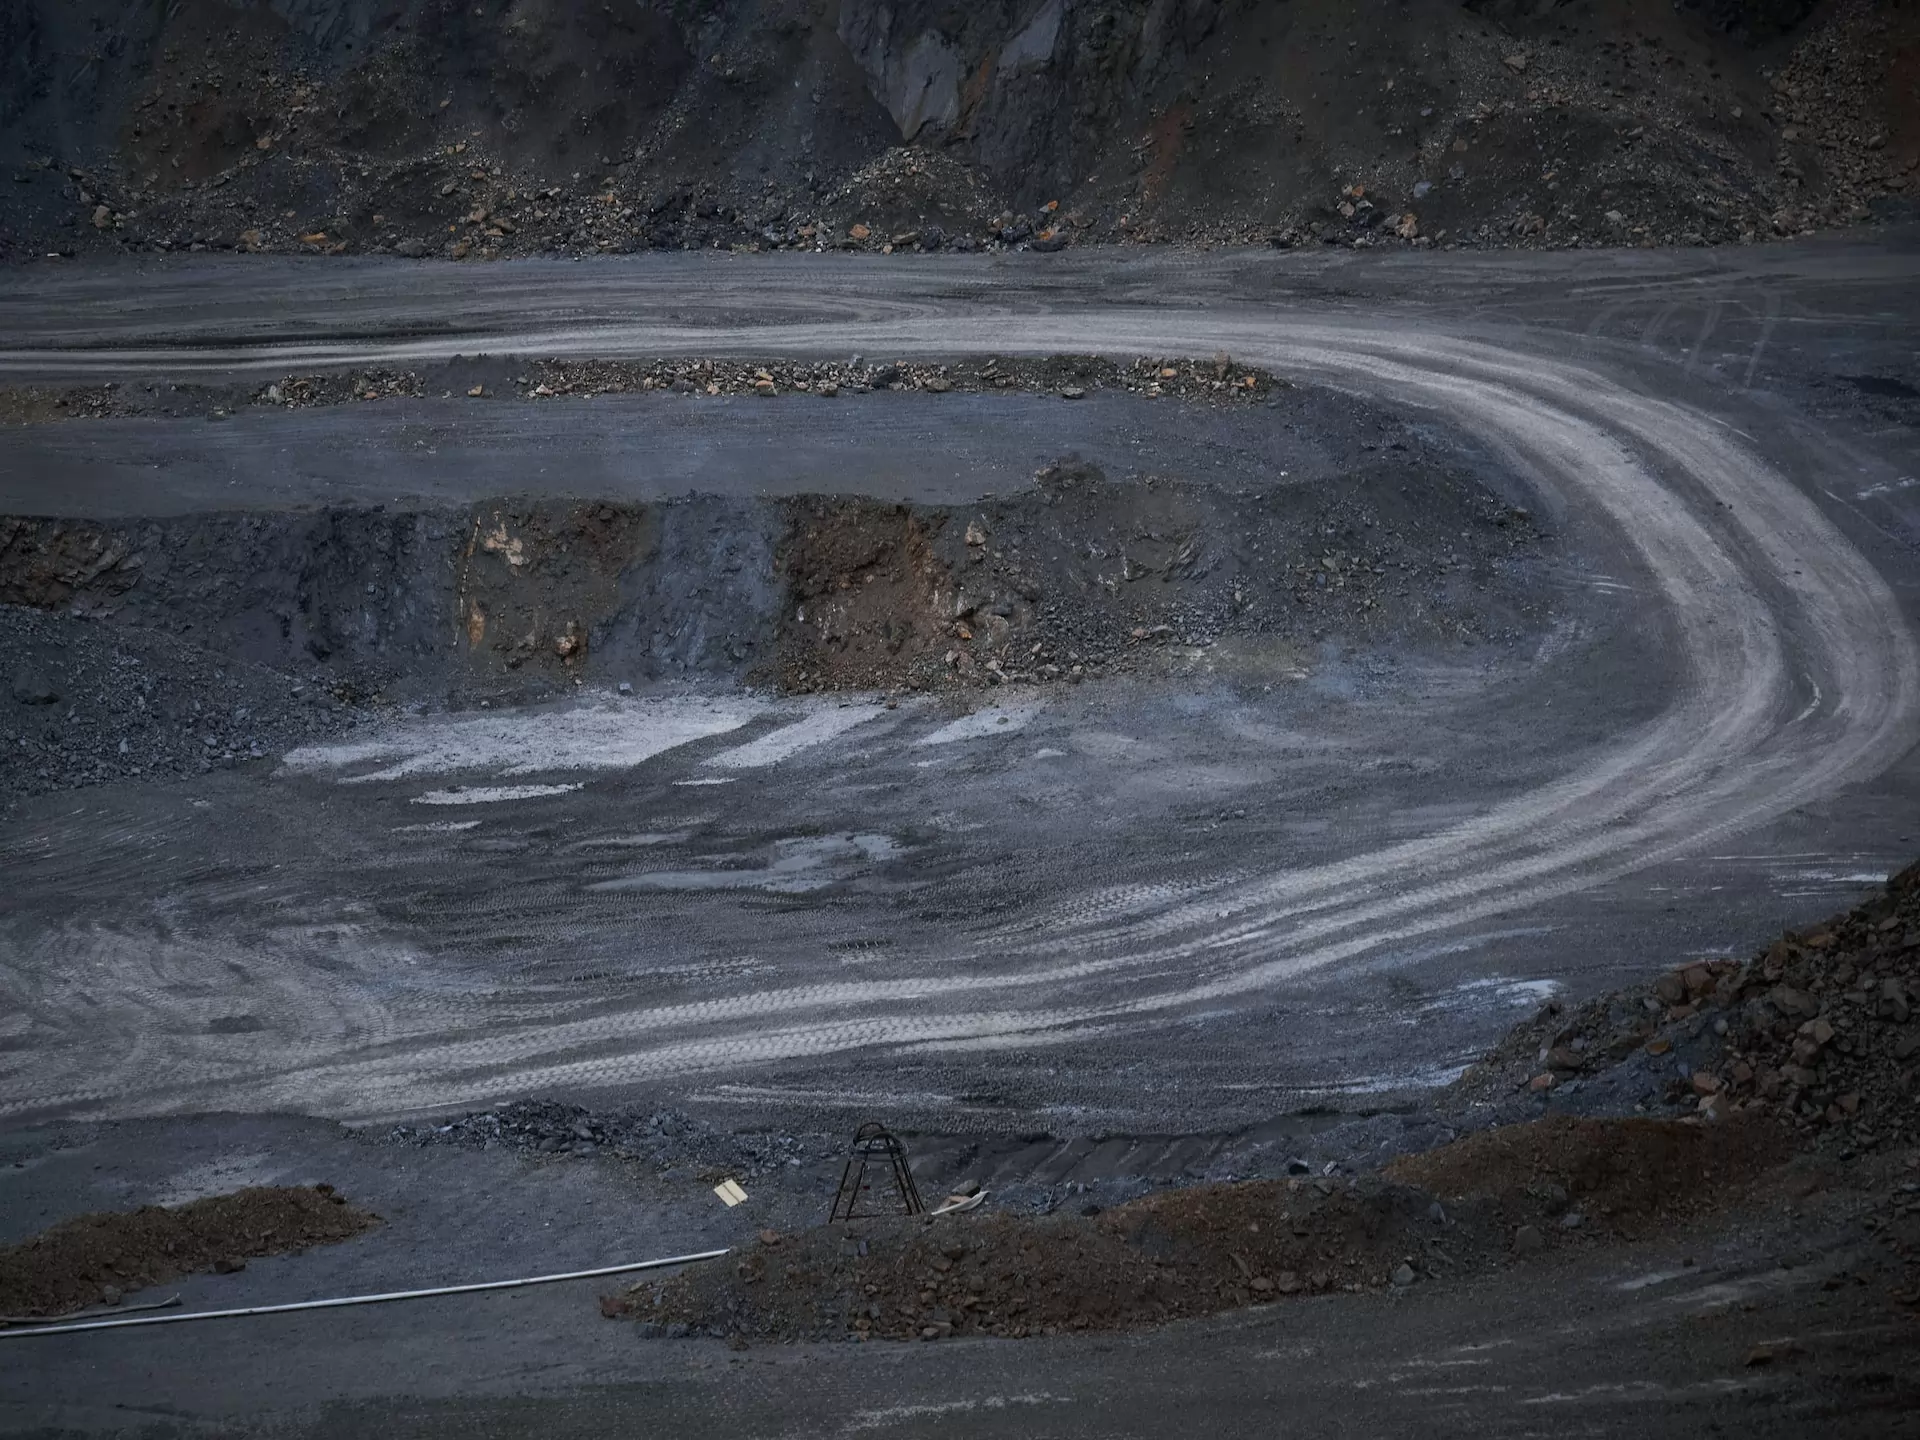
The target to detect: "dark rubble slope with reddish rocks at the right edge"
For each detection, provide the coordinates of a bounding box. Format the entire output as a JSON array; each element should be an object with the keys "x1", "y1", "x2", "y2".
[{"x1": 1459, "y1": 862, "x2": 1920, "y2": 1150}]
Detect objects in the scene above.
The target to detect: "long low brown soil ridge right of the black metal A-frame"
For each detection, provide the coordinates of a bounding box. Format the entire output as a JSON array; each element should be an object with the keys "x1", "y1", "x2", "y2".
[{"x1": 601, "y1": 1119, "x2": 1778, "y2": 1340}]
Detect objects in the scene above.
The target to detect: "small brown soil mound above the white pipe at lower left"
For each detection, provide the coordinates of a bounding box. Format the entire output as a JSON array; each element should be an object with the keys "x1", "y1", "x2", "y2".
[{"x1": 0, "y1": 1185, "x2": 380, "y2": 1315}]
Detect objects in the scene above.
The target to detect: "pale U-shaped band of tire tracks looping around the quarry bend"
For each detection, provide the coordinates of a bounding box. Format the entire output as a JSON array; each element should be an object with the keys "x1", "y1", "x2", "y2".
[{"x1": 0, "y1": 259, "x2": 1920, "y2": 1119}]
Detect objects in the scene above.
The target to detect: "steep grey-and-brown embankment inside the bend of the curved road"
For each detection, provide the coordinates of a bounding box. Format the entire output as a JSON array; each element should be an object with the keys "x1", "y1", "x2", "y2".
[{"x1": 0, "y1": 453, "x2": 1544, "y2": 705}]
